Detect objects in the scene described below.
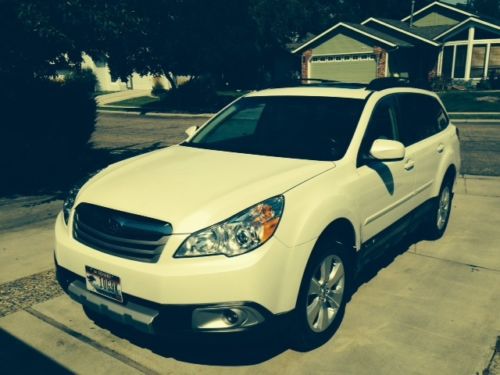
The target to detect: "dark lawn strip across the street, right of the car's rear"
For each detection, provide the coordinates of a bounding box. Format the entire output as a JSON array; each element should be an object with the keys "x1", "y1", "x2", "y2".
[{"x1": 438, "y1": 91, "x2": 500, "y2": 112}]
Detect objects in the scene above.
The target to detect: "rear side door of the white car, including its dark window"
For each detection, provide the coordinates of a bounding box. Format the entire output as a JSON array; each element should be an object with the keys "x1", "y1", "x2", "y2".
[{"x1": 396, "y1": 93, "x2": 448, "y2": 208}]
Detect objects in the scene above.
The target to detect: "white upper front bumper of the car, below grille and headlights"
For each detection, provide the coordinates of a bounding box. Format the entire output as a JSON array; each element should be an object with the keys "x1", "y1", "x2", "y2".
[{"x1": 55, "y1": 215, "x2": 314, "y2": 315}]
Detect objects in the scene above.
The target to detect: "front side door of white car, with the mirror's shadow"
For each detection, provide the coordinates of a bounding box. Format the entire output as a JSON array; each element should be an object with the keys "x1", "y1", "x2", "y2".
[{"x1": 355, "y1": 96, "x2": 414, "y2": 242}]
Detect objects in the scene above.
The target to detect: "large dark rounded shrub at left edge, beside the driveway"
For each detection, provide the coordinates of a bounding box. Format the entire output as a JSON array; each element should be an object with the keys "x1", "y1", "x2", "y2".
[{"x1": 0, "y1": 76, "x2": 96, "y2": 192}]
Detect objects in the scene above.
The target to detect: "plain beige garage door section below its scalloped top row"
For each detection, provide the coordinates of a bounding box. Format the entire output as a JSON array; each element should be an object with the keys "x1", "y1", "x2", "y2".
[{"x1": 310, "y1": 60, "x2": 376, "y2": 83}]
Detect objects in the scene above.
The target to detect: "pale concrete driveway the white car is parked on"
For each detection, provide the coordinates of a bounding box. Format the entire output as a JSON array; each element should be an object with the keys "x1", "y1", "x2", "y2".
[{"x1": 0, "y1": 178, "x2": 500, "y2": 375}]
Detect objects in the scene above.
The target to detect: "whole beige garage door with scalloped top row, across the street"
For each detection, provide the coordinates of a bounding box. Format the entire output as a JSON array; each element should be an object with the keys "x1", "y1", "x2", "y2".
[{"x1": 309, "y1": 54, "x2": 377, "y2": 83}]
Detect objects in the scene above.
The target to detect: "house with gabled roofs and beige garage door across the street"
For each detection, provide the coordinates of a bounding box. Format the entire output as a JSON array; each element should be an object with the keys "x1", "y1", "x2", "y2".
[{"x1": 293, "y1": 1, "x2": 500, "y2": 83}]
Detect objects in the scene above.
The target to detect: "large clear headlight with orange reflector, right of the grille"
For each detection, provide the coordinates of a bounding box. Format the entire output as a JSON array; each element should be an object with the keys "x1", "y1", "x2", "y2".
[{"x1": 175, "y1": 196, "x2": 285, "y2": 258}]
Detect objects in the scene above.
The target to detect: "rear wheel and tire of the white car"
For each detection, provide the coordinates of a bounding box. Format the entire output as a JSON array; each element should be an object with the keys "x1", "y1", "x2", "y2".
[{"x1": 424, "y1": 178, "x2": 453, "y2": 240}]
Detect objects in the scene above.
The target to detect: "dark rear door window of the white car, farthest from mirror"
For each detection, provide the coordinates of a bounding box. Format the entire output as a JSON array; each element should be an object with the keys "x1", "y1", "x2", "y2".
[{"x1": 398, "y1": 94, "x2": 448, "y2": 146}]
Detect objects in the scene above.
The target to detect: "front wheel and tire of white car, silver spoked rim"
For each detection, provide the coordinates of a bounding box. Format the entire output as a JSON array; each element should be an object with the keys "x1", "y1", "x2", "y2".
[{"x1": 290, "y1": 242, "x2": 354, "y2": 352}]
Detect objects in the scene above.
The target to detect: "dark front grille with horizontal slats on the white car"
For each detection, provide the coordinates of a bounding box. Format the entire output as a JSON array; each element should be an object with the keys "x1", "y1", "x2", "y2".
[{"x1": 73, "y1": 203, "x2": 172, "y2": 263}]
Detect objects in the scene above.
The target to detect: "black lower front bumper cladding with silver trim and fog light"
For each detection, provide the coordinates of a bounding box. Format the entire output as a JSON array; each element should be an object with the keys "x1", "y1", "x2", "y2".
[{"x1": 56, "y1": 263, "x2": 291, "y2": 335}]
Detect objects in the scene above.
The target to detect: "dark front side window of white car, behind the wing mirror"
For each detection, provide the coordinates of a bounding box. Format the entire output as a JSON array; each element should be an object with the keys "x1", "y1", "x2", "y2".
[{"x1": 358, "y1": 96, "x2": 398, "y2": 165}]
